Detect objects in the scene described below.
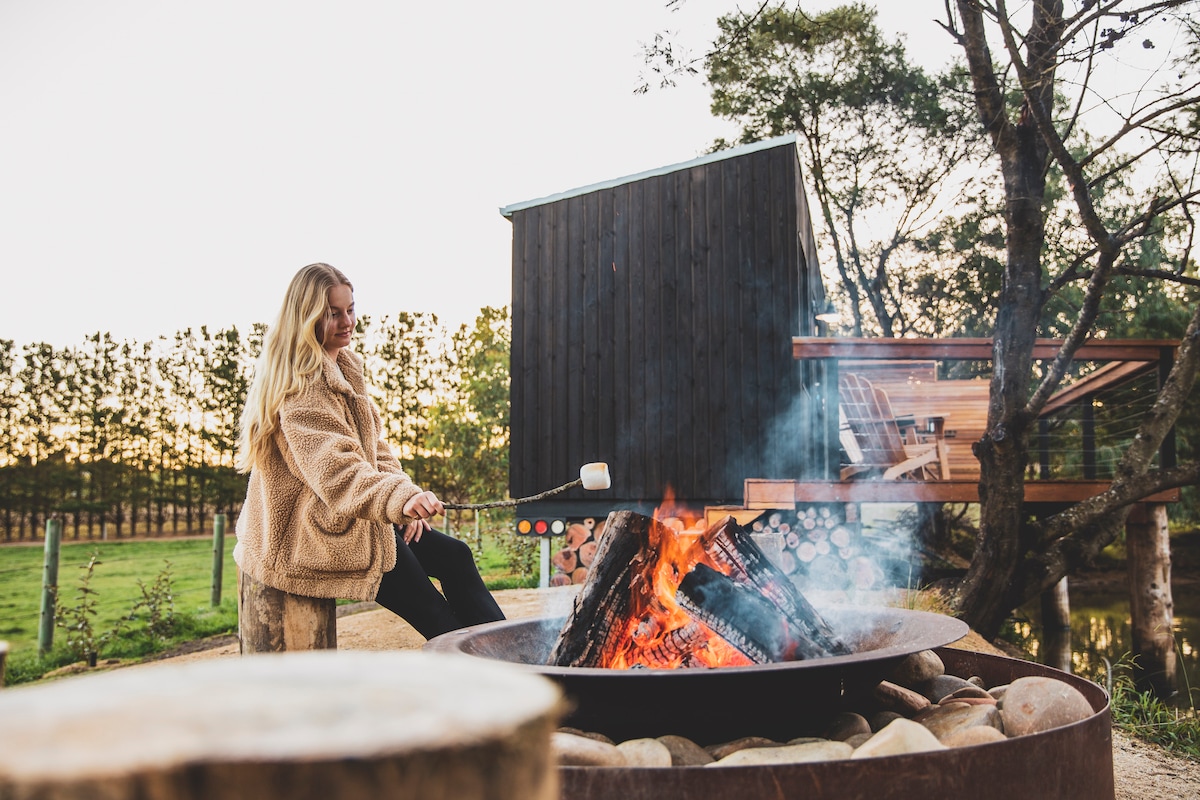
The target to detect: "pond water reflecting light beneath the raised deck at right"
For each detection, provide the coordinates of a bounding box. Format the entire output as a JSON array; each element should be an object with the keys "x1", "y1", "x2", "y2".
[{"x1": 1004, "y1": 582, "x2": 1200, "y2": 706}]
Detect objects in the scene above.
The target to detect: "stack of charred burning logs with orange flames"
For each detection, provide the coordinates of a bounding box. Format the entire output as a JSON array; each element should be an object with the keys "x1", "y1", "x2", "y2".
[{"x1": 547, "y1": 511, "x2": 847, "y2": 669}]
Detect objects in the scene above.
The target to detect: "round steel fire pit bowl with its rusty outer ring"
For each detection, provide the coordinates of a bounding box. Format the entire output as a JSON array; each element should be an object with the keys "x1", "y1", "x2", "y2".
[{"x1": 426, "y1": 609, "x2": 1116, "y2": 800}]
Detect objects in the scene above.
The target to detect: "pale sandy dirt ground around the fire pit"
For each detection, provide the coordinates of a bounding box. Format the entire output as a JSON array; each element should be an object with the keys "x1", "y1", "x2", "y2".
[{"x1": 124, "y1": 587, "x2": 1200, "y2": 800}]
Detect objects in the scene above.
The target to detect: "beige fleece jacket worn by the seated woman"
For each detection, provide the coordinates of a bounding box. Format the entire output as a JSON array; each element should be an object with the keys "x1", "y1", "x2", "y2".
[{"x1": 233, "y1": 349, "x2": 420, "y2": 600}]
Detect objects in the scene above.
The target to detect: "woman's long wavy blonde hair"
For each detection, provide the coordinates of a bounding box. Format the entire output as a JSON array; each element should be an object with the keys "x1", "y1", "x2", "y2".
[{"x1": 234, "y1": 264, "x2": 354, "y2": 473}]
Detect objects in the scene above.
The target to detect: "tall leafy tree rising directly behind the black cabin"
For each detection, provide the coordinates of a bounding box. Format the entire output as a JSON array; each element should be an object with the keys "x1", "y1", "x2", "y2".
[{"x1": 706, "y1": 4, "x2": 985, "y2": 336}]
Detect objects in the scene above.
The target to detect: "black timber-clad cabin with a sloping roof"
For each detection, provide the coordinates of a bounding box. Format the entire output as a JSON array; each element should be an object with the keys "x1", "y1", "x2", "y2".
[{"x1": 500, "y1": 136, "x2": 838, "y2": 529}]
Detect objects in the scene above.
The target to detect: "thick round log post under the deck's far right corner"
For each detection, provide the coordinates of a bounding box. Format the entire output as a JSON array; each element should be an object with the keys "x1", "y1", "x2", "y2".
[{"x1": 1126, "y1": 503, "x2": 1178, "y2": 699}]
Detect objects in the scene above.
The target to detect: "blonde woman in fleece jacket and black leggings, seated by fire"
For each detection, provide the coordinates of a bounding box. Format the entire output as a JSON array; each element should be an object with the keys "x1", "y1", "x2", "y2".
[{"x1": 234, "y1": 264, "x2": 504, "y2": 638}]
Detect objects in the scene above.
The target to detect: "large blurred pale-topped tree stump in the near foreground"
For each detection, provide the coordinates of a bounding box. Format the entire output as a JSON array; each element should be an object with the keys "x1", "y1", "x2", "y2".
[{"x1": 0, "y1": 651, "x2": 562, "y2": 800}]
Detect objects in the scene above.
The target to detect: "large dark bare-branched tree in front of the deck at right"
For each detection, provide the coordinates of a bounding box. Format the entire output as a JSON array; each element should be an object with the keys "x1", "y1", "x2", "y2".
[{"x1": 944, "y1": 0, "x2": 1200, "y2": 636}]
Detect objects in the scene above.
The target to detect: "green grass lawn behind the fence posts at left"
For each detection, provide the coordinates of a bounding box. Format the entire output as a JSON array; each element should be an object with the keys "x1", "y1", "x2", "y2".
[{"x1": 0, "y1": 534, "x2": 536, "y2": 684}]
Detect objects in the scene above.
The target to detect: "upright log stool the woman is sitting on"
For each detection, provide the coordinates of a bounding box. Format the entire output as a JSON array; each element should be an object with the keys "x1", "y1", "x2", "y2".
[{"x1": 238, "y1": 571, "x2": 337, "y2": 655}]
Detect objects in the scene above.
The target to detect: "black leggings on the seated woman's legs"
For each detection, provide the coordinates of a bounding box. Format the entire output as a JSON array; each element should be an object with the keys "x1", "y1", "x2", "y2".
[{"x1": 376, "y1": 530, "x2": 504, "y2": 639}]
